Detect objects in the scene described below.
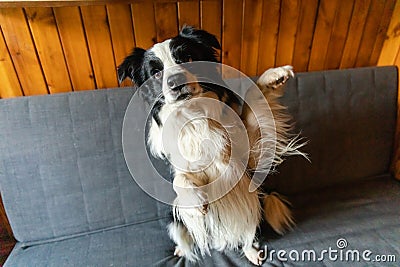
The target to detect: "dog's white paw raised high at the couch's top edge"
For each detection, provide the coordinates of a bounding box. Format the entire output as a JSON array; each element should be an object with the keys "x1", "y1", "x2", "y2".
[{"x1": 257, "y1": 65, "x2": 294, "y2": 89}]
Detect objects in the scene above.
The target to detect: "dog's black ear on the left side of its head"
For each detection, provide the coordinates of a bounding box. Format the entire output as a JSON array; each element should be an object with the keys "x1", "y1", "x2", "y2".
[{"x1": 118, "y1": 47, "x2": 146, "y2": 84}]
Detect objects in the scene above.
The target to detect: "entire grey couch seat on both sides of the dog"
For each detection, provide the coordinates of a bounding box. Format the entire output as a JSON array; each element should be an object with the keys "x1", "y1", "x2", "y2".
[{"x1": 6, "y1": 177, "x2": 400, "y2": 267}]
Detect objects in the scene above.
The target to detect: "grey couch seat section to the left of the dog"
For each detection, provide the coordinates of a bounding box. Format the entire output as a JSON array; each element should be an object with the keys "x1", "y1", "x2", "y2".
[{"x1": 5, "y1": 220, "x2": 173, "y2": 267}]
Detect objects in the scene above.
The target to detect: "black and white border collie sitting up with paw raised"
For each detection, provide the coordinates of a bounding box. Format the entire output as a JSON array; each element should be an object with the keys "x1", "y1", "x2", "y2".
[{"x1": 118, "y1": 26, "x2": 304, "y2": 265}]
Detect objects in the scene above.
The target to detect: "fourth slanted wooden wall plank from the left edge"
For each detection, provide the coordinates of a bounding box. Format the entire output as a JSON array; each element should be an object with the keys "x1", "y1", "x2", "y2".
[{"x1": 53, "y1": 7, "x2": 96, "y2": 91}]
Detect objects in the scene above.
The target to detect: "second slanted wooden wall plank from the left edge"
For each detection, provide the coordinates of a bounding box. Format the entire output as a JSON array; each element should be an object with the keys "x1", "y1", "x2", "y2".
[{"x1": 0, "y1": 8, "x2": 48, "y2": 95}]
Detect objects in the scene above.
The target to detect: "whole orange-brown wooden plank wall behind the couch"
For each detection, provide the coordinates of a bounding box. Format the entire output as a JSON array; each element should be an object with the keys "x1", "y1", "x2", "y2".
[{"x1": 0, "y1": 0, "x2": 400, "y2": 97}]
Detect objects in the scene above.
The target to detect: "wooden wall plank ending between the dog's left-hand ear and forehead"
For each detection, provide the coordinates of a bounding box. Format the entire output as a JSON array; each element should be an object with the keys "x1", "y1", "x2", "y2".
[{"x1": 131, "y1": 2, "x2": 157, "y2": 49}]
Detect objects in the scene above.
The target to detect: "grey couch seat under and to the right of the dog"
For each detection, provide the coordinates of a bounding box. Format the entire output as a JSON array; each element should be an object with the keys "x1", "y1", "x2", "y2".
[{"x1": 152, "y1": 176, "x2": 400, "y2": 267}]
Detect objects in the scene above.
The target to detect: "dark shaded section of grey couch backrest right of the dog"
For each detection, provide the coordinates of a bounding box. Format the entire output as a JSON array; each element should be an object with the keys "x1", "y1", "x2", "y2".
[{"x1": 267, "y1": 66, "x2": 398, "y2": 194}]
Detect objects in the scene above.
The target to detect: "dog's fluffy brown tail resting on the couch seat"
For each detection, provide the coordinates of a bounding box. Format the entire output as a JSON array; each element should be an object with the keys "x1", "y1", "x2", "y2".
[{"x1": 264, "y1": 192, "x2": 295, "y2": 235}]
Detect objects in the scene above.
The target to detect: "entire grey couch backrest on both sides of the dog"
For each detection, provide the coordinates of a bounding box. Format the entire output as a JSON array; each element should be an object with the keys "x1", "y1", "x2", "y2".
[{"x1": 0, "y1": 67, "x2": 397, "y2": 245}]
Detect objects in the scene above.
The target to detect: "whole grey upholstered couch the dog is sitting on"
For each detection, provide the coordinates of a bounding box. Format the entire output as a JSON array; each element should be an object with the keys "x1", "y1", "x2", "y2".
[{"x1": 0, "y1": 67, "x2": 400, "y2": 267}]
